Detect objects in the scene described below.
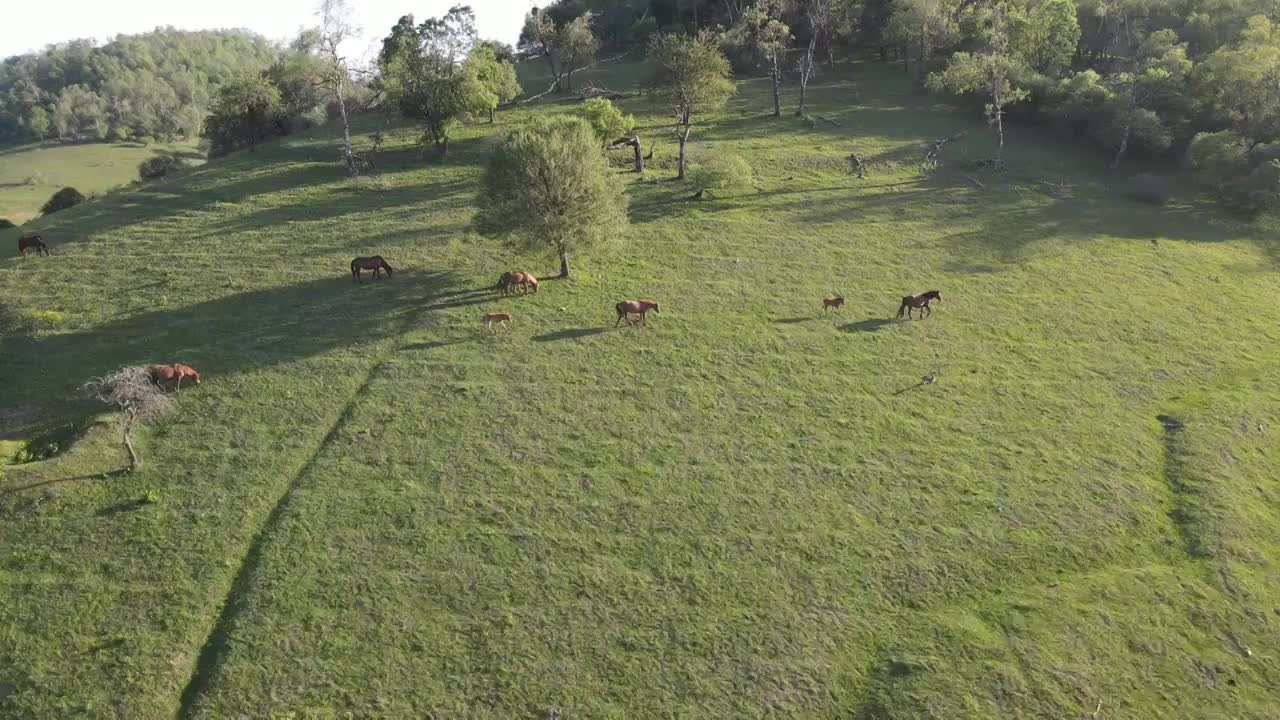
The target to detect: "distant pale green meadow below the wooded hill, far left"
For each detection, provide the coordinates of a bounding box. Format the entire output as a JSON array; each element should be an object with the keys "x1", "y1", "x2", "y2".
[{"x1": 0, "y1": 137, "x2": 195, "y2": 224}]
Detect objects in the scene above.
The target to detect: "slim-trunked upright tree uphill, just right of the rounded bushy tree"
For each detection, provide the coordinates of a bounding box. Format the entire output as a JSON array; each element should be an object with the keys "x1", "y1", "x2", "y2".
[{"x1": 644, "y1": 32, "x2": 737, "y2": 179}]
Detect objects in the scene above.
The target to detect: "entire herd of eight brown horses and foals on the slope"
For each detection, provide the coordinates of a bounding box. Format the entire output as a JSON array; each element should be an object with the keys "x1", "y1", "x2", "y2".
[{"x1": 18, "y1": 233, "x2": 942, "y2": 391}]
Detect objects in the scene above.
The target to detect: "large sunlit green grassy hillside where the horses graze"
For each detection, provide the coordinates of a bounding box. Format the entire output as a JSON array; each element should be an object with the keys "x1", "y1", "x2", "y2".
[{"x1": 0, "y1": 58, "x2": 1280, "y2": 720}]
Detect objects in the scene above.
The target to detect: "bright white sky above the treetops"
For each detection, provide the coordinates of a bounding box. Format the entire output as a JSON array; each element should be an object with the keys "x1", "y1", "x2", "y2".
[{"x1": 0, "y1": 0, "x2": 529, "y2": 63}]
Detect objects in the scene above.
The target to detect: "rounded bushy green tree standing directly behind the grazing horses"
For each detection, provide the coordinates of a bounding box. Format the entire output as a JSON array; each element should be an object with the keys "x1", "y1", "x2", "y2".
[{"x1": 475, "y1": 115, "x2": 627, "y2": 278}]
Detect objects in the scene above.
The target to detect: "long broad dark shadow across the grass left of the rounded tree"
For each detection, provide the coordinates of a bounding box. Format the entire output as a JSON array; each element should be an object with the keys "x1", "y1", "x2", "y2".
[{"x1": 0, "y1": 270, "x2": 471, "y2": 406}]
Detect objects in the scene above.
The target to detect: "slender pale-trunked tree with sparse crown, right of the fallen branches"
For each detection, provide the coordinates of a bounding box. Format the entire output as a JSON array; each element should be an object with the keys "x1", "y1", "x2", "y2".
[{"x1": 928, "y1": 0, "x2": 1027, "y2": 167}]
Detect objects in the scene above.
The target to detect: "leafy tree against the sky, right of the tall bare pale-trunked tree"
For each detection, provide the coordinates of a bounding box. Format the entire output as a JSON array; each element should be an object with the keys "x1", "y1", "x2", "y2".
[{"x1": 378, "y1": 5, "x2": 492, "y2": 159}]
